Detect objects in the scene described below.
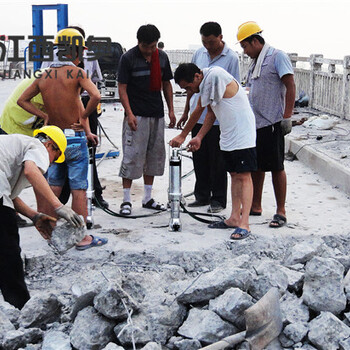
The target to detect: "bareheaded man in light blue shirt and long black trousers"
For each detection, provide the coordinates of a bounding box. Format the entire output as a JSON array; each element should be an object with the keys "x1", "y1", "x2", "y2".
[{"x1": 177, "y1": 22, "x2": 240, "y2": 213}]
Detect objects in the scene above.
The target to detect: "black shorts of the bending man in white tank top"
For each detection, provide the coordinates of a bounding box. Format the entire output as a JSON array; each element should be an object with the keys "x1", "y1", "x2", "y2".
[{"x1": 221, "y1": 147, "x2": 257, "y2": 173}]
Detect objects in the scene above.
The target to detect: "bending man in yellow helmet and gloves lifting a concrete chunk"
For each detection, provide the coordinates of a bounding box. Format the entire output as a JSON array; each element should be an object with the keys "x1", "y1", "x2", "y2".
[{"x1": 0, "y1": 126, "x2": 83, "y2": 309}]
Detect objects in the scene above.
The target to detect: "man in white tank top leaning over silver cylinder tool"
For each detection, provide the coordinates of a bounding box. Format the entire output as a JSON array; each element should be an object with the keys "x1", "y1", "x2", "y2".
[{"x1": 170, "y1": 63, "x2": 256, "y2": 240}]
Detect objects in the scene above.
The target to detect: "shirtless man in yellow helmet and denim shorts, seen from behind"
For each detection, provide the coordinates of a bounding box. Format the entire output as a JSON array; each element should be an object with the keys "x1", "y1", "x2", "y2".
[{"x1": 17, "y1": 29, "x2": 107, "y2": 250}]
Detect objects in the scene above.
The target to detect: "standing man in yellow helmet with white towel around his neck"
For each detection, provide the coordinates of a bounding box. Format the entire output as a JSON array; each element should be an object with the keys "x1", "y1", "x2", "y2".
[{"x1": 237, "y1": 22, "x2": 295, "y2": 228}]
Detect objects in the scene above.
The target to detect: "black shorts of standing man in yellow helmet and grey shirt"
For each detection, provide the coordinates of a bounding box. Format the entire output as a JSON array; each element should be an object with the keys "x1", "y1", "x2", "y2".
[{"x1": 256, "y1": 122, "x2": 284, "y2": 171}]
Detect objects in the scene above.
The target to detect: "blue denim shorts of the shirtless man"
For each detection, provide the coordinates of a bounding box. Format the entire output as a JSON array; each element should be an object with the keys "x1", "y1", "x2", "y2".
[{"x1": 47, "y1": 131, "x2": 89, "y2": 190}]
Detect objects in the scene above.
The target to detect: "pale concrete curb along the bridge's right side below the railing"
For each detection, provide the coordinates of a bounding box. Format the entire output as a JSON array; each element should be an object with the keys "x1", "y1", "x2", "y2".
[{"x1": 285, "y1": 135, "x2": 350, "y2": 194}]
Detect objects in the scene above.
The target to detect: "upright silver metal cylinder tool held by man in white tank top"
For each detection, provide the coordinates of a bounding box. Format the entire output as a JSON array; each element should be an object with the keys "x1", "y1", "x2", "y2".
[{"x1": 168, "y1": 148, "x2": 182, "y2": 231}]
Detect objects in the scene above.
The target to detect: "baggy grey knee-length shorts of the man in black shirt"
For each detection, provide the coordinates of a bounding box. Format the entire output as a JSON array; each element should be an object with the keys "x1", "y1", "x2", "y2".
[{"x1": 119, "y1": 116, "x2": 165, "y2": 180}]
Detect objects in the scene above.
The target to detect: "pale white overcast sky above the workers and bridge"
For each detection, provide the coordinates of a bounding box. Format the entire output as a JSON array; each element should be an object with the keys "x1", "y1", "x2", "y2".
[{"x1": 0, "y1": 0, "x2": 350, "y2": 59}]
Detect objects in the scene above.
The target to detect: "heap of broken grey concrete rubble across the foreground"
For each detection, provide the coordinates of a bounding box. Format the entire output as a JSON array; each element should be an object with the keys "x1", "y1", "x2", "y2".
[{"x1": 0, "y1": 232, "x2": 350, "y2": 350}]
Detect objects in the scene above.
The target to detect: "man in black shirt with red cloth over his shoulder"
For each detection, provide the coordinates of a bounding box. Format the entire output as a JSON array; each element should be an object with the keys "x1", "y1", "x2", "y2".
[{"x1": 118, "y1": 24, "x2": 176, "y2": 215}]
